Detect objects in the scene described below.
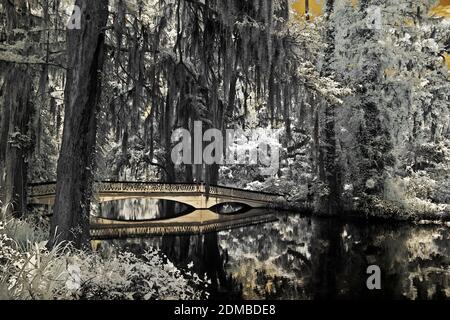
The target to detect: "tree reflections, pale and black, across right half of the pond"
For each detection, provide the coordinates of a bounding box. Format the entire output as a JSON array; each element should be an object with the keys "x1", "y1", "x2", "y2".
[{"x1": 219, "y1": 216, "x2": 450, "y2": 299}]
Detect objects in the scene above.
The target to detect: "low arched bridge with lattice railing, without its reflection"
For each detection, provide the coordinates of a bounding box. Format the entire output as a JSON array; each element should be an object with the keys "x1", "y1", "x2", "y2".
[{"x1": 28, "y1": 182, "x2": 280, "y2": 209}]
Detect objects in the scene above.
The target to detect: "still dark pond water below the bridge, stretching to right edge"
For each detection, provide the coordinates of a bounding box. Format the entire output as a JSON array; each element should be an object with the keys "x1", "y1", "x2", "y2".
[{"x1": 96, "y1": 200, "x2": 450, "y2": 299}]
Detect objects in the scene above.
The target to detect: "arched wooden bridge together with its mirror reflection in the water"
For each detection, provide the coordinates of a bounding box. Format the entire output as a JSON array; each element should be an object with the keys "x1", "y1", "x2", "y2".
[{"x1": 29, "y1": 182, "x2": 280, "y2": 239}]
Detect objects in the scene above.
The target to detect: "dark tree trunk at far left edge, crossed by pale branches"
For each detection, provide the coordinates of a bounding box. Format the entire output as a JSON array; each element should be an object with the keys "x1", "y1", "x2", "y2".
[{"x1": 0, "y1": 0, "x2": 33, "y2": 217}]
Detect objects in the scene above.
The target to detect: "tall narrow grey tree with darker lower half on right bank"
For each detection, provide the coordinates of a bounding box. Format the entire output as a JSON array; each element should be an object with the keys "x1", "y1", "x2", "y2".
[{"x1": 333, "y1": 0, "x2": 393, "y2": 206}]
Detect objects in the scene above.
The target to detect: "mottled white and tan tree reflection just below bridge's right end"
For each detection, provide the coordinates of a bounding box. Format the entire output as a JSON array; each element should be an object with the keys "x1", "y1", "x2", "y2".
[{"x1": 219, "y1": 216, "x2": 311, "y2": 299}]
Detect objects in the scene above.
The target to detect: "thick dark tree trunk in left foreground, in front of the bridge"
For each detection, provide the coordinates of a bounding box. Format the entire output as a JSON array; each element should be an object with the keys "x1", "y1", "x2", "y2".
[{"x1": 49, "y1": 0, "x2": 108, "y2": 248}]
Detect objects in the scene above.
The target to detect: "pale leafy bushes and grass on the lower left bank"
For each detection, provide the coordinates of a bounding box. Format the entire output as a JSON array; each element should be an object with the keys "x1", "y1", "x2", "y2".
[{"x1": 0, "y1": 219, "x2": 208, "y2": 300}]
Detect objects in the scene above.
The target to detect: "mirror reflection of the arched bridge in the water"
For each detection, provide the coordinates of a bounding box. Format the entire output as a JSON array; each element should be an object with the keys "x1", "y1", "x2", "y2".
[{"x1": 91, "y1": 210, "x2": 278, "y2": 240}]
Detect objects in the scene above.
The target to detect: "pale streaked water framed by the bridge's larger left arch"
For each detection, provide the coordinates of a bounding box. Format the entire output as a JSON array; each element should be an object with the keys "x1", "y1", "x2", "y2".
[{"x1": 97, "y1": 198, "x2": 193, "y2": 220}]
